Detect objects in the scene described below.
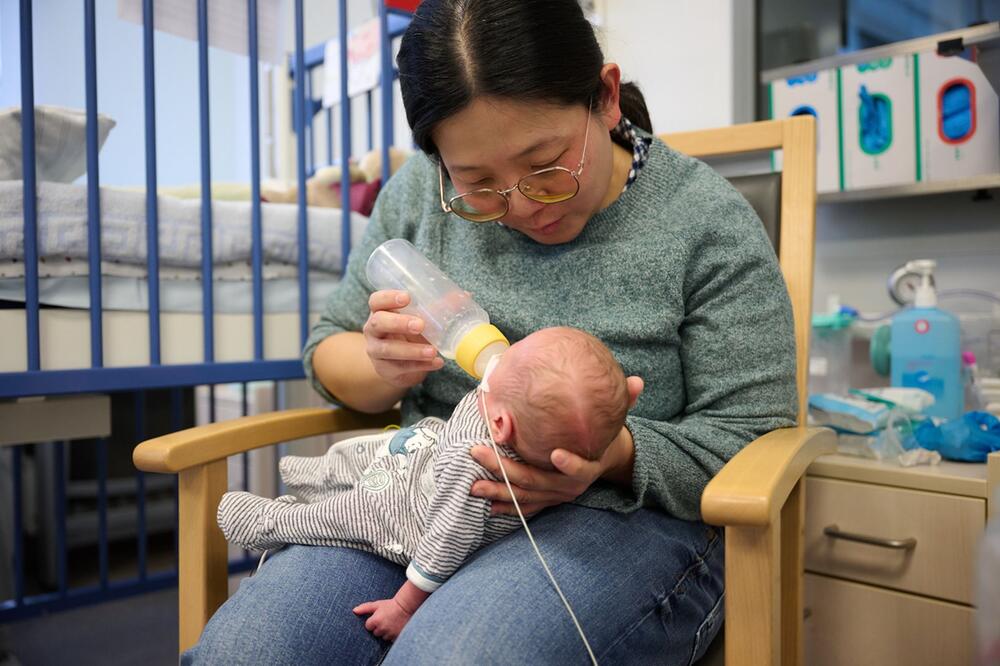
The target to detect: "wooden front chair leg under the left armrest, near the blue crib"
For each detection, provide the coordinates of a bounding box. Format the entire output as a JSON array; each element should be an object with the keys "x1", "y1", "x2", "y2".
[{"x1": 177, "y1": 460, "x2": 228, "y2": 652}]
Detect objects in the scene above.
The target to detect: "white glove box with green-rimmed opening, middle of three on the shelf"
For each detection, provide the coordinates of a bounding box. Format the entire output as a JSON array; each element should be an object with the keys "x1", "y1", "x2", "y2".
[{"x1": 839, "y1": 55, "x2": 919, "y2": 190}]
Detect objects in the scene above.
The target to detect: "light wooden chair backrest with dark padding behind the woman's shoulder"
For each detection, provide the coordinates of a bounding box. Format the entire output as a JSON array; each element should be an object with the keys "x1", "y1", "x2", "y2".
[{"x1": 660, "y1": 116, "x2": 816, "y2": 423}]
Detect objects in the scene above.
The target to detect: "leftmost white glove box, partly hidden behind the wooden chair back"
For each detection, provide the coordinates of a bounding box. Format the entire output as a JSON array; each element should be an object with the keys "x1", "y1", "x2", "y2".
[{"x1": 768, "y1": 69, "x2": 840, "y2": 192}]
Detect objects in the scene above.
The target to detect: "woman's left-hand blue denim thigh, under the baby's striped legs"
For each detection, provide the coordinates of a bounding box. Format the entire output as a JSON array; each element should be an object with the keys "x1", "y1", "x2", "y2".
[{"x1": 181, "y1": 546, "x2": 406, "y2": 666}]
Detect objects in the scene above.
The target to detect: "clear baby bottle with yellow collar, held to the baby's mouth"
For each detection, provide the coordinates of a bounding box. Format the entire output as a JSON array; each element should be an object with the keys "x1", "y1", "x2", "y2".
[{"x1": 365, "y1": 238, "x2": 510, "y2": 379}]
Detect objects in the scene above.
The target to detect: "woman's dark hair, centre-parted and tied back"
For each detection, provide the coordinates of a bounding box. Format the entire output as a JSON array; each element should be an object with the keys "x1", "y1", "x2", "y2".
[{"x1": 397, "y1": 0, "x2": 652, "y2": 155}]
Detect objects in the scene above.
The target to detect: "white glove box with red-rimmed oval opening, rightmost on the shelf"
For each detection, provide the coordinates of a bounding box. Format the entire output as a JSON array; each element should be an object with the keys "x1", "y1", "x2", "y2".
[{"x1": 917, "y1": 52, "x2": 1000, "y2": 180}]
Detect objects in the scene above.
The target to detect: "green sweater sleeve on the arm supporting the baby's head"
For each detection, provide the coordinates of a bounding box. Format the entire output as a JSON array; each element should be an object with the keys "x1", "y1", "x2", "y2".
[{"x1": 580, "y1": 192, "x2": 796, "y2": 520}]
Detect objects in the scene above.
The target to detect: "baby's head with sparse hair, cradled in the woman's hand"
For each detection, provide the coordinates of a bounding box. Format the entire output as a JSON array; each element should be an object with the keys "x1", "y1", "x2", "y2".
[{"x1": 486, "y1": 327, "x2": 630, "y2": 469}]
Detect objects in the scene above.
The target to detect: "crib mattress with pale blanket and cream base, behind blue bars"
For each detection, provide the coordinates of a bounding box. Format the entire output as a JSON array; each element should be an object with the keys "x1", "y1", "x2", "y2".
[{"x1": 0, "y1": 181, "x2": 367, "y2": 372}]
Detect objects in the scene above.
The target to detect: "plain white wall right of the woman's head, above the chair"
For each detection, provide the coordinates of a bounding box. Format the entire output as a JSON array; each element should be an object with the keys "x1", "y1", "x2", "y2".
[{"x1": 600, "y1": 0, "x2": 754, "y2": 132}]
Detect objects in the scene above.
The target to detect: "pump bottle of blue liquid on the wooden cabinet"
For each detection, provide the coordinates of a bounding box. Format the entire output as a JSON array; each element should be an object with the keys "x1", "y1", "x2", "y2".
[{"x1": 891, "y1": 259, "x2": 964, "y2": 419}]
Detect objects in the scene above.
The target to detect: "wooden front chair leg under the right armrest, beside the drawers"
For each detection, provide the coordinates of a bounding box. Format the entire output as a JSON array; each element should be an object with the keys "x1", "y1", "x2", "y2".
[{"x1": 726, "y1": 525, "x2": 781, "y2": 666}]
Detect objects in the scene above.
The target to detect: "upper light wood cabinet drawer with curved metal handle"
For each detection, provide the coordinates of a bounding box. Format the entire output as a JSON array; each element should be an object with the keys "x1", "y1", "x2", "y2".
[{"x1": 805, "y1": 477, "x2": 986, "y2": 604}]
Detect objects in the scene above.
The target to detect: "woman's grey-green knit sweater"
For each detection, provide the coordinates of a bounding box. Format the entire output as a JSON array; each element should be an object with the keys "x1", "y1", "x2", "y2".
[{"x1": 304, "y1": 140, "x2": 796, "y2": 520}]
